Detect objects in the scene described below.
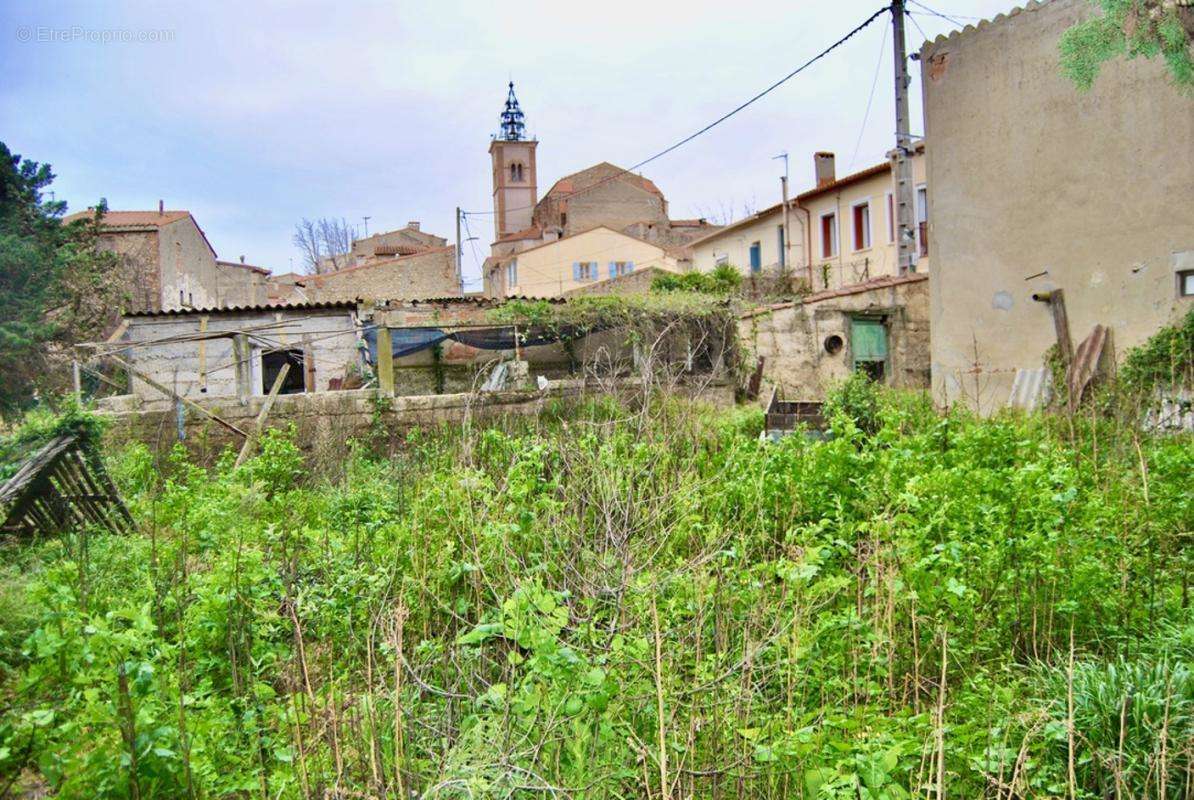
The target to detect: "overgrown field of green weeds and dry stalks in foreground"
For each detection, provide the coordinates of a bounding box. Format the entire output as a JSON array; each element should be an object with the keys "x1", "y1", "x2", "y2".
[{"x1": 0, "y1": 382, "x2": 1194, "y2": 799}]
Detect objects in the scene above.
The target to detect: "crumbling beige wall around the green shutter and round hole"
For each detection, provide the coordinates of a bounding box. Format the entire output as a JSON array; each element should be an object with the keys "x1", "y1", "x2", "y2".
[{"x1": 738, "y1": 276, "x2": 929, "y2": 401}]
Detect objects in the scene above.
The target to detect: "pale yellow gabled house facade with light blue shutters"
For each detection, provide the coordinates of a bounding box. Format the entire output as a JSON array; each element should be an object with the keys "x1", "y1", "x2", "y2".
[{"x1": 485, "y1": 226, "x2": 683, "y2": 297}]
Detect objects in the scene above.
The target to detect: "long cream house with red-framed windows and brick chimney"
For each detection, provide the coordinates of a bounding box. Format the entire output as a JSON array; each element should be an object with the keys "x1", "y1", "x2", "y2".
[{"x1": 691, "y1": 144, "x2": 929, "y2": 291}]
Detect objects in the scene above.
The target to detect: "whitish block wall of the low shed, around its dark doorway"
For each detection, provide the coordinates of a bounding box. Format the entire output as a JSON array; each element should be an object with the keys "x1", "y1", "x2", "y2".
[{"x1": 124, "y1": 309, "x2": 361, "y2": 402}]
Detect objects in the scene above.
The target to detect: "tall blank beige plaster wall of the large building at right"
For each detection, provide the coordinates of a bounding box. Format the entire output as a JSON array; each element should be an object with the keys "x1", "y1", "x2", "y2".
[{"x1": 921, "y1": 0, "x2": 1194, "y2": 411}]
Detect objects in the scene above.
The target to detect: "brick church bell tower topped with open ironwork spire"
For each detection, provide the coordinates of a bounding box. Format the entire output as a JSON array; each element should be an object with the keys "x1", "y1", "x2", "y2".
[{"x1": 490, "y1": 81, "x2": 538, "y2": 244}]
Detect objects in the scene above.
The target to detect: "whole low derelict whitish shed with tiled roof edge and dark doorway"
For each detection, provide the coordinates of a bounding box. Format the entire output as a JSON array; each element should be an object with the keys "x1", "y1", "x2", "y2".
[{"x1": 96, "y1": 302, "x2": 363, "y2": 401}]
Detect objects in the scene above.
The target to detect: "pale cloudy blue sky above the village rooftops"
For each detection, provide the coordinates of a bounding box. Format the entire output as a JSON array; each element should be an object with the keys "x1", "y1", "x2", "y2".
[{"x1": 0, "y1": 0, "x2": 1014, "y2": 287}]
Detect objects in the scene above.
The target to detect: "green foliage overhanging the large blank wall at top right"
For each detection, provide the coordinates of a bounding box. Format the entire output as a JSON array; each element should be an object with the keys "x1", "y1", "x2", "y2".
[{"x1": 1060, "y1": 0, "x2": 1194, "y2": 93}]
